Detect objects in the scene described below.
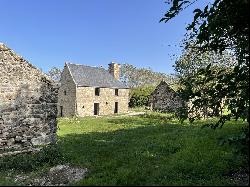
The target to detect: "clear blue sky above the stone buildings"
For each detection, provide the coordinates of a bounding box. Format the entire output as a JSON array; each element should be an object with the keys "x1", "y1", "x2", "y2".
[{"x1": 0, "y1": 0, "x2": 211, "y2": 74}]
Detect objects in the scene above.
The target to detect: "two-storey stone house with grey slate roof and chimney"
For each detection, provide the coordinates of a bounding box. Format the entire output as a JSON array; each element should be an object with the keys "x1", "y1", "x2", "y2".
[{"x1": 58, "y1": 63, "x2": 129, "y2": 117}]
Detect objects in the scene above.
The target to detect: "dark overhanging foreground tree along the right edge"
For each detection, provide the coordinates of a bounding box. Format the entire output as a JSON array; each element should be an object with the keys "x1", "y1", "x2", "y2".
[{"x1": 160, "y1": 0, "x2": 249, "y2": 127}]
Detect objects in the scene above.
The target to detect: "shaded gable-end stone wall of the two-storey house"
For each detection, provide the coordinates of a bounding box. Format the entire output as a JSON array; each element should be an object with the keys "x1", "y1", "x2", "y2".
[{"x1": 57, "y1": 65, "x2": 76, "y2": 117}]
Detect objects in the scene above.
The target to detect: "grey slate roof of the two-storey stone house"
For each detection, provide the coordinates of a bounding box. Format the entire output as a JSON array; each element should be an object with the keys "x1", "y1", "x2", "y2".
[{"x1": 67, "y1": 63, "x2": 128, "y2": 88}]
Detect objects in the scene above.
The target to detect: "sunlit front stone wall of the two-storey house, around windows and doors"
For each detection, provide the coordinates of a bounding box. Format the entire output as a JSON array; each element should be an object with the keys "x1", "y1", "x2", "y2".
[{"x1": 76, "y1": 87, "x2": 129, "y2": 116}]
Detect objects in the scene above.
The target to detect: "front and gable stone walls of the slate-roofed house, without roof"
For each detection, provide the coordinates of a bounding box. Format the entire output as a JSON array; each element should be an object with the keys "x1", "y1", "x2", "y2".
[{"x1": 58, "y1": 64, "x2": 129, "y2": 117}]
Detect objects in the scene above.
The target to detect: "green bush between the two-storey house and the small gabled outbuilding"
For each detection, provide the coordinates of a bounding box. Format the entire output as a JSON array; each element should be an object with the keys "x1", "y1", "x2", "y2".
[{"x1": 129, "y1": 86, "x2": 155, "y2": 107}]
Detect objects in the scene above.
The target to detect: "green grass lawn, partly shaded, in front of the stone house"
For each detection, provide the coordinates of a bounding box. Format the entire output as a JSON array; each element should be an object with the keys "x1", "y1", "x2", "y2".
[{"x1": 0, "y1": 113, "x2": 247, "y2": 186}]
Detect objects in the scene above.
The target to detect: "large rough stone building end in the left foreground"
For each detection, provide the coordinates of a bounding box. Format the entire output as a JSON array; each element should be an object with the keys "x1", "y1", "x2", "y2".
[{"x1": 0, "y1": 43, "x2": 58, "y2": 153}]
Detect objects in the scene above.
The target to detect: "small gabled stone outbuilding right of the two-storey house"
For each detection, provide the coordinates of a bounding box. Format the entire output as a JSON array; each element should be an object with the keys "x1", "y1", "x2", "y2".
[{"x1": 149, "y1": 81, "x2": 183, "y2": 112}]
